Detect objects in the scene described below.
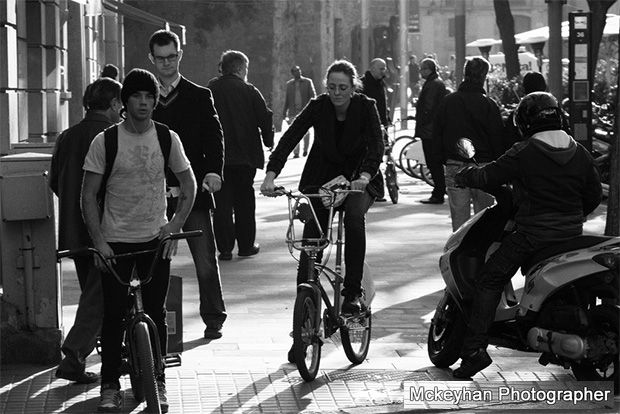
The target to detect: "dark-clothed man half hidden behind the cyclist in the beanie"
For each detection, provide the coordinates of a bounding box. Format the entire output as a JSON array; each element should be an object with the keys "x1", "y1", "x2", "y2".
[{"x1": 50, "y1": 78, "x2": 122, "y2": 384}]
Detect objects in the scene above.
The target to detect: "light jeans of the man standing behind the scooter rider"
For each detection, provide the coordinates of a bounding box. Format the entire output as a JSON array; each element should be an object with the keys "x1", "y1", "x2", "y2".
[{"x1": 445, "y1": 160, "x2": 494, "y2": 231}]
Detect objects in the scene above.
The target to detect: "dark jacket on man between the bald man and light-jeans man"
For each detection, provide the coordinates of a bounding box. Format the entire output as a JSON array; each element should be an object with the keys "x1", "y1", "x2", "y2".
[{"x1": 415, "y1": 72, "x2": 448, "y2": 139}]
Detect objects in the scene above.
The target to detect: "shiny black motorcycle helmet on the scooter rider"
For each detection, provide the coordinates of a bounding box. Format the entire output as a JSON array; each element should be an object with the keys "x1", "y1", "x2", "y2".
[{"x1": 514, "y1": 92, "x2": 562, "y2": 138}]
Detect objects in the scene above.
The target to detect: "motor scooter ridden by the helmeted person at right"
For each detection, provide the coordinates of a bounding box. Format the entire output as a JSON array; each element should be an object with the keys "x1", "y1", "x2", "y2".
[{"x1": 428, "y1": 138, "x2": 620, "y2": 394}]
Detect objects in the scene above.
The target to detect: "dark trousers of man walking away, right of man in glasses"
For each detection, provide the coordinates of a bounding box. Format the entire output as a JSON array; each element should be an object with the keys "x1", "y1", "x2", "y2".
[{"x1": 213, "y1": 165, "x2": 256, "y2": 253}]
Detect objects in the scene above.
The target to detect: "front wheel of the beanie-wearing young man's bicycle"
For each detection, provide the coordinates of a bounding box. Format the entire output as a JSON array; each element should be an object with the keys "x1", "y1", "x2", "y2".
[{"x1": 131, "y1": 322, "x2": 161, "y2": 413}]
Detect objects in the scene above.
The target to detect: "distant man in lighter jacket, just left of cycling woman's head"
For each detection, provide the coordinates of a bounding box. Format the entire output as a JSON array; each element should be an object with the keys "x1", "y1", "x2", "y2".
[{"x1": 282, "y1": 65, "x2": 316, "y2": 158}]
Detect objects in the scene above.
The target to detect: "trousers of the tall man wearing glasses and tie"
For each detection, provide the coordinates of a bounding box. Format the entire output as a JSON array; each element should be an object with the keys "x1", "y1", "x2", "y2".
[{"x1": 168, "y1": 198, "x2": 227, "y2": 326}]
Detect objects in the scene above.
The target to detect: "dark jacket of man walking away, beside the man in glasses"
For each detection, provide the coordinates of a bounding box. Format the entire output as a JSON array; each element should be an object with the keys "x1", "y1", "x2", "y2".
[{"x1": 209, "y1": 75, "x2": 274, "y2": 169}]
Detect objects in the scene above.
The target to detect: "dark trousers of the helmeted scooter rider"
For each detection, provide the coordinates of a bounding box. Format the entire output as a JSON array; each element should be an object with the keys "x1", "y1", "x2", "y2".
[{"x1": 462, "y1": 231, "x2": 547, "y2": 355}]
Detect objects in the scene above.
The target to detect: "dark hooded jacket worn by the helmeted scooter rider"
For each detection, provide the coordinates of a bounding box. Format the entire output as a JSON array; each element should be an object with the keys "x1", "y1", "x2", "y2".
[{"x1": 459, "y1": 131, "x2": 601, "y2": 242}]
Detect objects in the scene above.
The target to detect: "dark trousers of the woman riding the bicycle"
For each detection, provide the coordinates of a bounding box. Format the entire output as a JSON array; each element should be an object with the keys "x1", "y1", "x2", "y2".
[{"x1": 297, "y1": 191, "x2": 374, "y2": 296}]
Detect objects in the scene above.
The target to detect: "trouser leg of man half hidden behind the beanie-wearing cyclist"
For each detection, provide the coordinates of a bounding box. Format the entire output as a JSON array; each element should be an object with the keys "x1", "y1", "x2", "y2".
[{"x1": 59, "y1": 256, "x2": 103, "y2": 373}]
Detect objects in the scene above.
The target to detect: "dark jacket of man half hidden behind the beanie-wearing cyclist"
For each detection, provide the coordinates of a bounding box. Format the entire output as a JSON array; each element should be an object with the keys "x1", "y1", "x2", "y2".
[{"x1": 50, "y1": 111, "x2": 113, "y2": 250}]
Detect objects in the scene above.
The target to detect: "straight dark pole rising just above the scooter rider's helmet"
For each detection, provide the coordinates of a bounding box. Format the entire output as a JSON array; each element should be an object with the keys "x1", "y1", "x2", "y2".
[{"x1": 546, "y1": 0, "x2": 566, "y2": 101}]
